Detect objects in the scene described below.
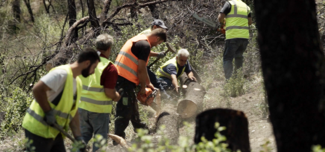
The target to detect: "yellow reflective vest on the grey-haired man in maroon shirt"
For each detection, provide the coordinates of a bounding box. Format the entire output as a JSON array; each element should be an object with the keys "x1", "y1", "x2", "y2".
[{"x1": 79, "y1": 57, "x2": 113, "y2": 113}]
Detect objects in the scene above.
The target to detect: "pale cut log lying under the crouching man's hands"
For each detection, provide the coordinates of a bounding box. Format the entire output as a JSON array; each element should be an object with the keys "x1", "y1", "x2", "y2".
[{"x1": 177, "y1": 73, "x2": 206, "y2": 118}]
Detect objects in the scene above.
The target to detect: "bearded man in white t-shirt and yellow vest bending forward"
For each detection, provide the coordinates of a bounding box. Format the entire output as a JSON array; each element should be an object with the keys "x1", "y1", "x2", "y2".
[{"x1": 22, "y1": 49, "x2": 99, "y2": 152}]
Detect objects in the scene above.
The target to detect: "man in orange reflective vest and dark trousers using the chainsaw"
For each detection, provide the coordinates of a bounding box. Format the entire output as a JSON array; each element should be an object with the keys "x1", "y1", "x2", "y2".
[{"x1": 114, "y1": 28, "x2": 167, "y2": 145}]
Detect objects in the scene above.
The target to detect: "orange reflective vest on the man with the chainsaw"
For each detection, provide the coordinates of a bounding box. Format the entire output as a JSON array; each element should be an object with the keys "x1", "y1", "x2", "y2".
[{"x1": 115, "y1": 35, "x2": 151, "y2": 85}]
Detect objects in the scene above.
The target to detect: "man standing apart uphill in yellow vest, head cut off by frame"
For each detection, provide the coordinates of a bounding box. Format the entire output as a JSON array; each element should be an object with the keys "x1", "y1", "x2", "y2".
[{"x1": 218, "y1": 0, "x2": 252, "y2": 80}]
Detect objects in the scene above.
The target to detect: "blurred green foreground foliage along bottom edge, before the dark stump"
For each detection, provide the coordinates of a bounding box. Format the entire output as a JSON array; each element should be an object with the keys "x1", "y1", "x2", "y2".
[{"x1": 129, "y1": 123, "x2": 231, "y2": 152}]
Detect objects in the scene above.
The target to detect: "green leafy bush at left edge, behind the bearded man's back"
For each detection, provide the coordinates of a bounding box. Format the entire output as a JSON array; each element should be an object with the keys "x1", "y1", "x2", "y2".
[{"x1": 0, "y1": 88, "x2": 32, "y2": 138}]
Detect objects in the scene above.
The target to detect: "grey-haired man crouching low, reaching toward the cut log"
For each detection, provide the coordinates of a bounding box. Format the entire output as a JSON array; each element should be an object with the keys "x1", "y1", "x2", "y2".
[{"x1": 156, "y1": 49, "x2": 196, "y2": 93}]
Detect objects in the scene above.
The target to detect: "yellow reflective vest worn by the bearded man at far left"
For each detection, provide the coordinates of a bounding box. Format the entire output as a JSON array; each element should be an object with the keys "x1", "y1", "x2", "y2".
[{"x1": 23, "y1": 65, "x2": 82, "y2": 138}]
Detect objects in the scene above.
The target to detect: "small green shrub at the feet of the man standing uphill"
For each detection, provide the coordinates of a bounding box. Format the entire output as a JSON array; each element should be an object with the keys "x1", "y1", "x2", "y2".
[{"x1": 224, "y1": 68, "x2": 245, "y2": 97}]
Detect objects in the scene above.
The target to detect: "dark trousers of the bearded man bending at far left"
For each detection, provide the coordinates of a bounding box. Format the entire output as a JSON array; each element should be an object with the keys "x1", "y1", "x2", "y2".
[{"x1": 25, "y1": 129, "x2": 65, "y2": 152}]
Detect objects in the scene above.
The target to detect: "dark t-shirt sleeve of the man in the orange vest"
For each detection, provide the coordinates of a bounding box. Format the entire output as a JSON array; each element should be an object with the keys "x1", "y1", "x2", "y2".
[{"x1": 131, "y1": 40, "x2": 150, "y2": 62}]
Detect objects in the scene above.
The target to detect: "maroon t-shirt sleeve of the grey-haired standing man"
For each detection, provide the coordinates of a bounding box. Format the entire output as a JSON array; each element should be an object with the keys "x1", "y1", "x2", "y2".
[{"x1": 100, "y1": 54, "x2": 118, "y2": 89}]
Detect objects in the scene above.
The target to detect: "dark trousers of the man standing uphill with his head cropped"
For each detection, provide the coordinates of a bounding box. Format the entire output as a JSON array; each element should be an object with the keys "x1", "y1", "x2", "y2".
[{"x1": 223, "y1": 39, "x2": 248, "y2": 79}]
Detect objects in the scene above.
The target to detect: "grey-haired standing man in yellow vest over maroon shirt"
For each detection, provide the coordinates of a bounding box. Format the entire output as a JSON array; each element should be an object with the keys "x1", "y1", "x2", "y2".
[{"x1": 79, "y1": 34, "x2": 121, "y2": 152}]
